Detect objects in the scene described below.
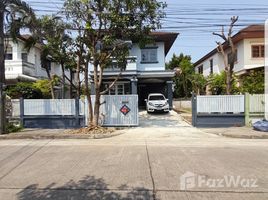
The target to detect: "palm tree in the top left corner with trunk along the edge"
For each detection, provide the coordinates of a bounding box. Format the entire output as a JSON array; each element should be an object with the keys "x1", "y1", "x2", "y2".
[{"x1": 0, "y1": 0, "x2": 35, "y2": 134}]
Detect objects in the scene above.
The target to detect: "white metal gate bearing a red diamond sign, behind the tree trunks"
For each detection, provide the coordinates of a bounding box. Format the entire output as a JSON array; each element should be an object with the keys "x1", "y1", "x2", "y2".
[{"x1": 80, "y1": 95, "x2": 139, "y2": 126}]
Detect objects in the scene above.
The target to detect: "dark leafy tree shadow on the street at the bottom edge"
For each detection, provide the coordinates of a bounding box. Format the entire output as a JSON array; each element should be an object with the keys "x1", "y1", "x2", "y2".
[{"x1": 17, "y1": 176, "x2": 153, "y2": 200}]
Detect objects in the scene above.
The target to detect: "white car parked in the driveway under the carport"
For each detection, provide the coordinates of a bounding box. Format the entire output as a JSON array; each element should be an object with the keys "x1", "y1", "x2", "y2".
[{"x1": 145, "y1": 93, "x2": 169, "y2": 112}]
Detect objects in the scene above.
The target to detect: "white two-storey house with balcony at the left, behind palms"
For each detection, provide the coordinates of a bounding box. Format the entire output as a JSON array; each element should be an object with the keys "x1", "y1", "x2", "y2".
[{"x1": 5, "y1": 35, "x2": 71, "y2": 97}]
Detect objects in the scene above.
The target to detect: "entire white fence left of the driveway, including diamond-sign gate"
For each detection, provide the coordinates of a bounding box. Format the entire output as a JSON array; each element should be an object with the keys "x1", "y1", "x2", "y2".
[{"x1": 12, "y1": 95, "x2": 139, "y2": 126}]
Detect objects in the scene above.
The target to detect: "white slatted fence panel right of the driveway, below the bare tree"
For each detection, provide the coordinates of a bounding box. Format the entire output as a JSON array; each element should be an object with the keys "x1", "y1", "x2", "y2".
[{"x1": 197, "y1": 95, "x2": 245, "y2": 113}]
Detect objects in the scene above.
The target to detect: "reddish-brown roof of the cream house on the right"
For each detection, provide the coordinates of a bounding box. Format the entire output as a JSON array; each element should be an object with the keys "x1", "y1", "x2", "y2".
[{"x1": 194, "y1": 24, "x2": 265, "y2": 67}]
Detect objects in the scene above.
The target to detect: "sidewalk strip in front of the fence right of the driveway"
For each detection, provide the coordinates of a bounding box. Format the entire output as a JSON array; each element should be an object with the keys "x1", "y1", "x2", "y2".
[{"x1": 199, "y1": 127, "x2": 268, "y2": 139}]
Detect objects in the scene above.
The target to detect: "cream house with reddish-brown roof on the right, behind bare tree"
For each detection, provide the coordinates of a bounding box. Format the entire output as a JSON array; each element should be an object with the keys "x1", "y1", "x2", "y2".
[{"x1": 194, "y1": 25, "x2": 265, "y2": 76}]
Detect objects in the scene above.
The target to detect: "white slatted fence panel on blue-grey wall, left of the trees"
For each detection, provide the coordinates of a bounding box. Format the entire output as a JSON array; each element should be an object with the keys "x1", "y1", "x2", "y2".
[{"x1": 24, "y1": 99, "x2": 75, "y2": 115}]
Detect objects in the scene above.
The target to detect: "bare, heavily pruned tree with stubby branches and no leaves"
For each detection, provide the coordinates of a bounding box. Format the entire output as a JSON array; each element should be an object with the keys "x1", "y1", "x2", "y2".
[{"x1": 213, "y1": 16, "x2": 238, "y2": 95}]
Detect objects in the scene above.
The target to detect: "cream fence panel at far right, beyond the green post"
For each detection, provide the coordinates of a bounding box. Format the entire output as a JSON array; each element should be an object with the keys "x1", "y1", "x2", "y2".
[{"x1": 249, "y1": 94, "x2": 265, "y2": 113}]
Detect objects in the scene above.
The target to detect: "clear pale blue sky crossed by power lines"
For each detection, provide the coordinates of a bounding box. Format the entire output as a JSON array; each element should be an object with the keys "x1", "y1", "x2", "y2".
[{"x1": 25, "y1": 0, "x2": 268, "y2": 62}]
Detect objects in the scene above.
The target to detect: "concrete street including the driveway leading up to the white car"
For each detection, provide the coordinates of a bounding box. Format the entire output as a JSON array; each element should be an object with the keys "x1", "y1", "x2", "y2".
[{"x1": 0, "y1": 112, "x2": 268, "y2": 200}]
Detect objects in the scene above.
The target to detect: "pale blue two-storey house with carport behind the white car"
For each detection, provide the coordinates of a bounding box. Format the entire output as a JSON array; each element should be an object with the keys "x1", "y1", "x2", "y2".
[{"x1": 90, "y1": 32, "x2": 178, "y2": 107}]
